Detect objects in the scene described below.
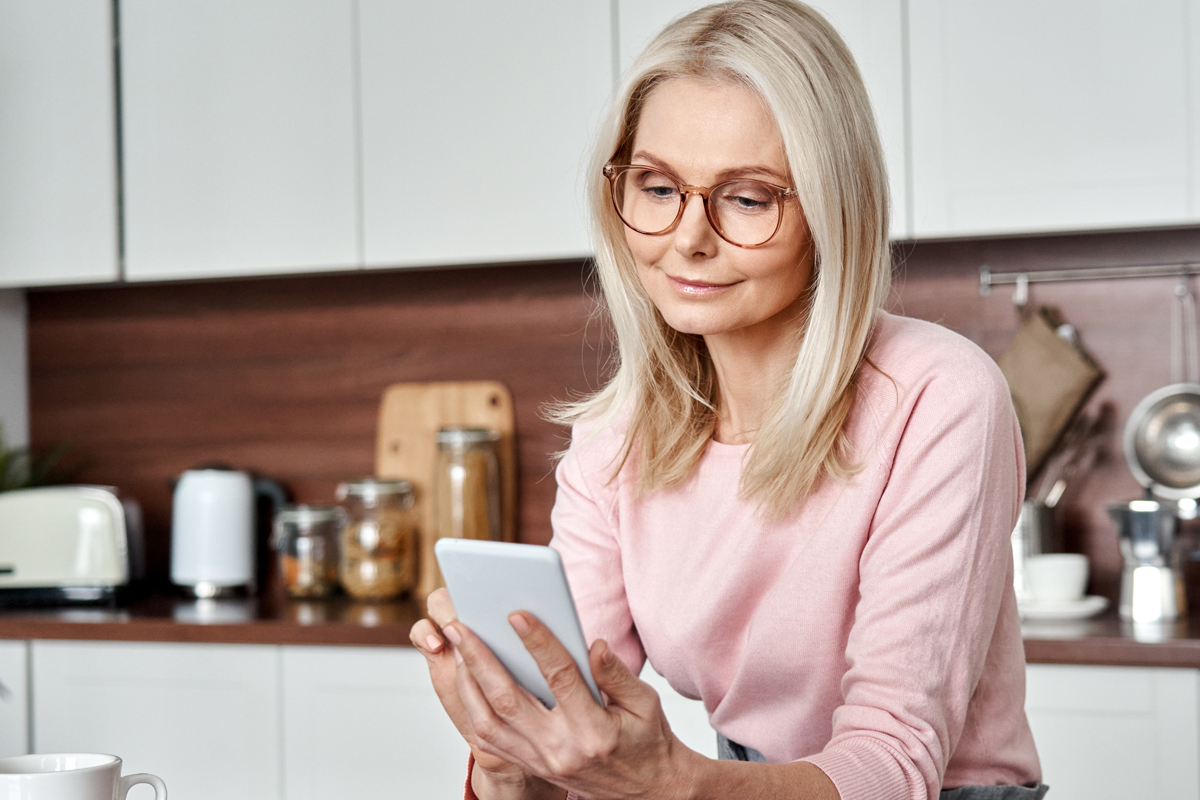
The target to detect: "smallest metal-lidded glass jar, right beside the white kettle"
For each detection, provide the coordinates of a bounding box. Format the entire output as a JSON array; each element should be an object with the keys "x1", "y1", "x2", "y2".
[{"x1": 271, "y1": 505, "x2": 342, "y2": 597}]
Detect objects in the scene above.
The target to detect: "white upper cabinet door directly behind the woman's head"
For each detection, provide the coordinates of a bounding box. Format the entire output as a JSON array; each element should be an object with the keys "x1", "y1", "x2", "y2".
[{"x1": 617, "y1": 0, "x2": 910, "y2": 239}]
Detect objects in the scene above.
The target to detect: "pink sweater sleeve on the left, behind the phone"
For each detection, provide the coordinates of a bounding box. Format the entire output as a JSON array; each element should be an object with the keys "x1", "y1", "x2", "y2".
[{"x1": 550, "y1": 428, "x2": 646, "y2": 675}]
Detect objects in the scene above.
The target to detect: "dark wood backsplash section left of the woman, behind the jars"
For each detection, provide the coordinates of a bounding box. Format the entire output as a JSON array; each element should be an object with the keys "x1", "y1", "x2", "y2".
[{"x1": 30, "y1": 261, "x2": 606, "y2": 583}]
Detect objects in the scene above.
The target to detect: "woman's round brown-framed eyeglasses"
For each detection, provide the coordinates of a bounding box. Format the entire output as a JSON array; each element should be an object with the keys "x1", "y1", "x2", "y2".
[{"x1": 604, "y1": 164, "x2": 796, "y2": 247}]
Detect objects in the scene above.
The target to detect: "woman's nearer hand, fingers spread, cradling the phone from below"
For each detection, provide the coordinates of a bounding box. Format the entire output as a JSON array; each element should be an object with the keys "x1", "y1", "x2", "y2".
[{"x1": 445, "y1": 612, "x2": 703, "y2": 800}]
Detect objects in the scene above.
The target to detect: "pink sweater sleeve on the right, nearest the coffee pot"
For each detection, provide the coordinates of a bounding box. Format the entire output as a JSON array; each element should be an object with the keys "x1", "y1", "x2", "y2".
[{"x1": 806, "y1": 353, "x2": 1025, "y2": 800}]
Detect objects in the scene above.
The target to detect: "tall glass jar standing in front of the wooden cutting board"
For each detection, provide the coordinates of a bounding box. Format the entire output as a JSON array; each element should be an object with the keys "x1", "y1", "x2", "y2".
[{"x1": 433, "y1": 427, "x2": 503, "y2": 541}]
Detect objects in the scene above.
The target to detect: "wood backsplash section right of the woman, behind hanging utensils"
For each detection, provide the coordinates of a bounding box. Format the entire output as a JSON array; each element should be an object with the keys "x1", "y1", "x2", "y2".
[{"x1": 893, "y1": 228, "x2": 1200, "y2": 603}]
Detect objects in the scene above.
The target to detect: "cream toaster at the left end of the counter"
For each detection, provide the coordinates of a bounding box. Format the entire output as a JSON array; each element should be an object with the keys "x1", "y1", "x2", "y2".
[{"x1": 0, "y1": 486, "x2": 130, "y2": 606}]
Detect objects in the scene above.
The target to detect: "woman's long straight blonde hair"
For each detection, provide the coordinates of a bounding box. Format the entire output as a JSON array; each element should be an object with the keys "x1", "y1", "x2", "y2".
[{"x1": 551, "y1": 0, "x2": 890, "y2": 516}]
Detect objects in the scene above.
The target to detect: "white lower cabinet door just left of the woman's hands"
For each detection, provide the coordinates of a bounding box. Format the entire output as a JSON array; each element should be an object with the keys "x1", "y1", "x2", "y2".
[{"x1": 282, "y1": 646, "x2": 468, "y2": 800}]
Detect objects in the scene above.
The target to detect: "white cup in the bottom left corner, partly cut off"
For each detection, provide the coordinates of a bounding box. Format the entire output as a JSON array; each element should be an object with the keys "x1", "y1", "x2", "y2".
[{"x1": 0, "y1": 753, "x2": 167, "y2": 800}]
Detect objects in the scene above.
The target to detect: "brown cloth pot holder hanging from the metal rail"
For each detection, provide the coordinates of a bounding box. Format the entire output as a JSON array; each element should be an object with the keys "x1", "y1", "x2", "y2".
[{"x1": 1000, "y1": 308, "x2": 1104, "y2": 482}]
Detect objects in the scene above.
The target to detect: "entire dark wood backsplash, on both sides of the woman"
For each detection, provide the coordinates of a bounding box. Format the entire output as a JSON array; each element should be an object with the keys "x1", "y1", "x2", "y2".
[{"x1": 29, "y1": 229, "x2": 1200, "y2": 596}]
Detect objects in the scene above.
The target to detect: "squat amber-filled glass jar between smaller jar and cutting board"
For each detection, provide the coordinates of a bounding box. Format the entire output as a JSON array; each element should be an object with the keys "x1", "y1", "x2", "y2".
[{"x1": 337, "y1": 477, "x2": 416, "y2": 600}]
